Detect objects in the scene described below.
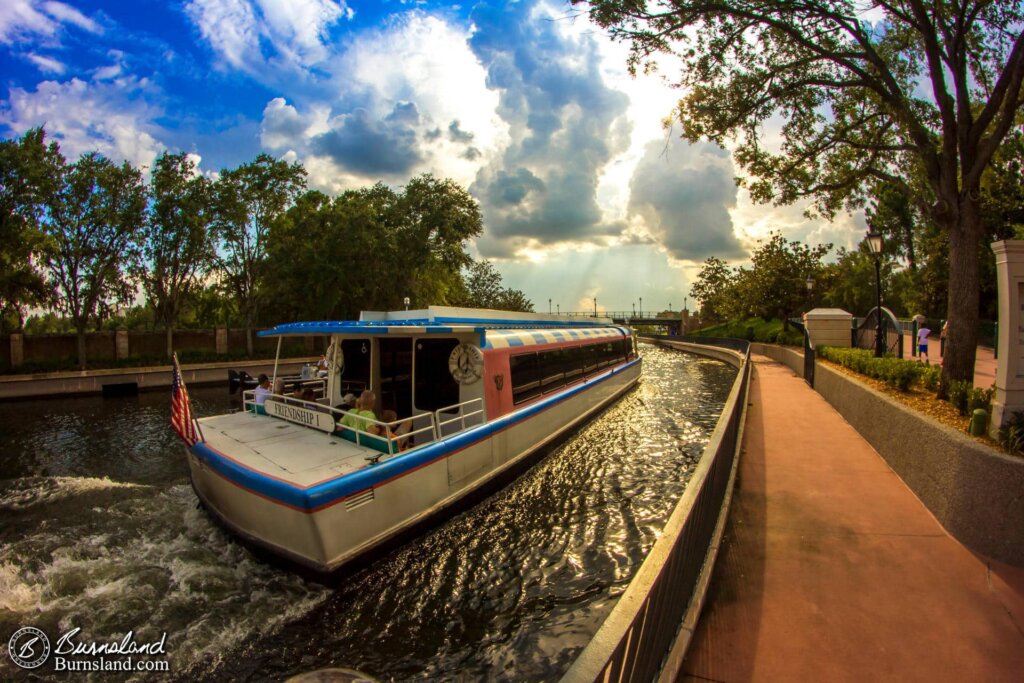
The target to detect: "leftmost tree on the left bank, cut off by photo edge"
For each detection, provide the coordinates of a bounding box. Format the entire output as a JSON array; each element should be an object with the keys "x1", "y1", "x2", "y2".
[{"x1": 0, "y1": 128, "x2": 62, "y2": 329}]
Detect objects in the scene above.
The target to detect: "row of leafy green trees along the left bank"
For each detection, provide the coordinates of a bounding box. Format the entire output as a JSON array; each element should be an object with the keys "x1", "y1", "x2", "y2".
[{"x1": 0, "y1": 129, "x2": 532, "y2": 366}]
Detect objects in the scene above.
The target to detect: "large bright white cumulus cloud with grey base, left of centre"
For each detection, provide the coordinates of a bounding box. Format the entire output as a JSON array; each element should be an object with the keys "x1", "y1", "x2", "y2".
[{"x1": 251, "y1": 10, "x2": 506, "y2": 191}]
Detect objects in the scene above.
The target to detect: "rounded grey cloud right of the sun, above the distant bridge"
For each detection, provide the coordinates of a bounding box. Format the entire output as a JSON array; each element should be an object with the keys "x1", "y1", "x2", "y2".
[{"x1": 629, "y1": 140, "x2": 746, "y2": 261}]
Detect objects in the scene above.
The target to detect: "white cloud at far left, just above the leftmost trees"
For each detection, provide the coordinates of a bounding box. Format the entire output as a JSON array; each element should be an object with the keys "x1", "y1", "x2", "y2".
[{"x1": 0, "y1": 78, "x2": 165, "y2": 174}]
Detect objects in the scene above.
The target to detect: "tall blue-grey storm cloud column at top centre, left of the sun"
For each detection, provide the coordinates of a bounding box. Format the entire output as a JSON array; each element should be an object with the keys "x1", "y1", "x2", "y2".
[{"x1": 470, "y1": 2, "x2": 628, "y2": 250}]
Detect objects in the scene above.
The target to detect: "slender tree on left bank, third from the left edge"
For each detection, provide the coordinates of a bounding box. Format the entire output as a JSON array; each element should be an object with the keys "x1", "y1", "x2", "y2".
[{"x1": 142, "y1": 152, "x2": 214, "y2": 357}]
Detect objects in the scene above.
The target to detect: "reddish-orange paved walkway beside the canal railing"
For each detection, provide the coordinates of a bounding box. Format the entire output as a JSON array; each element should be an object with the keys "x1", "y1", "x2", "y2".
[{"x1": 681, "y1": 356, "x2": 1024, "y2": 683}]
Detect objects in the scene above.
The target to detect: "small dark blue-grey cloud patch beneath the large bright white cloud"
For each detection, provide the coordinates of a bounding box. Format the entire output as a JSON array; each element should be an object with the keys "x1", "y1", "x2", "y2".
[{"x1": 310, "y1": 103, "x2": 422, "y2": 175}]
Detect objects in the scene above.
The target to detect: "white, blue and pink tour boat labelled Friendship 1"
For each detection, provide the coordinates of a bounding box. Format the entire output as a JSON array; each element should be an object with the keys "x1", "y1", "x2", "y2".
[{"x1": 180, "y1": 306, "x2": 641, "y2": 571}]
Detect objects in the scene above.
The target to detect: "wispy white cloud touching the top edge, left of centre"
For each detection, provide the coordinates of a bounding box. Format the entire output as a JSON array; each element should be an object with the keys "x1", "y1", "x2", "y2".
[{"x1": 185, "y1": 0, "x2": 353, "y2": 79}]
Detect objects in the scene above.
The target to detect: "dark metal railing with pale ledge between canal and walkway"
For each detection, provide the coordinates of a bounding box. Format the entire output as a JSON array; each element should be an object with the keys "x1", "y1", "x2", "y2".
[{"x1": 562, "y1": 337, "x2": 750, "y2": 683}]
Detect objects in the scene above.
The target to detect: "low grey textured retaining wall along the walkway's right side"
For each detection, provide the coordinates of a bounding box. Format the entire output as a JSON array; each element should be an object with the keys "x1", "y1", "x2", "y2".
[{"x1": 751, "y1": 344, "x2": 1024, "y2": 566}]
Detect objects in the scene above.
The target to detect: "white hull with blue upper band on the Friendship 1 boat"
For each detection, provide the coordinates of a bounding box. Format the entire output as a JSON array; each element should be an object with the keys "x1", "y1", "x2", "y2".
[{"x1": 188, "y1": 359, "x2": 641, "y2": 571}]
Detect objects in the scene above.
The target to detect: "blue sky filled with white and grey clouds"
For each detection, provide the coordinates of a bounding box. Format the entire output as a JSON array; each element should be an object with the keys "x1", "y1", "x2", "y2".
[{"x1": 0, "y1": 0, "x2": 864, "y2": 311}]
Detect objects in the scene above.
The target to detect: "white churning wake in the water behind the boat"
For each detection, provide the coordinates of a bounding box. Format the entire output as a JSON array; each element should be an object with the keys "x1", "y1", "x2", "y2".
[{"x1": 0, "y1": 477, "x2": 328, "y2": 680}]
